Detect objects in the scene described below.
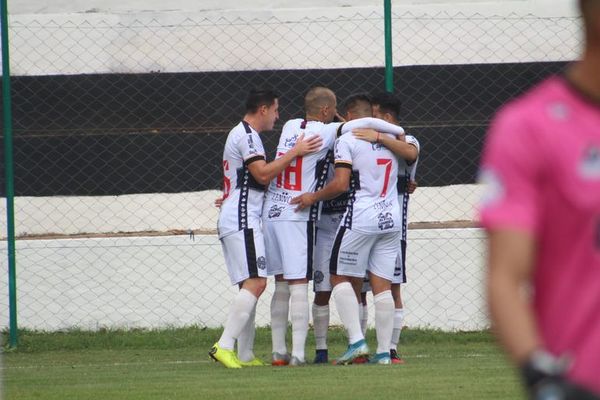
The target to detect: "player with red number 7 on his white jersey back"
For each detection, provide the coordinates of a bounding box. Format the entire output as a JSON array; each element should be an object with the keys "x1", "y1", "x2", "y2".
[{"x1": 291, "y1": 94, "x2": 403, "y2": 364}]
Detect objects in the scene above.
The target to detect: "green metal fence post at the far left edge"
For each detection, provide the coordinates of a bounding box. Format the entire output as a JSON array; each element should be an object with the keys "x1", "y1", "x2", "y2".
[{"x1": 0, "y1": 0, "x2": 18, "y2": 348}]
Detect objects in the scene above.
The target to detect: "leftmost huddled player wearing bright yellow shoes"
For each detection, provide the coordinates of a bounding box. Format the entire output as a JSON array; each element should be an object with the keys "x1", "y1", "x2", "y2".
[{"x1": 209, "y1": 90, "x2": 321, "y2": 368}]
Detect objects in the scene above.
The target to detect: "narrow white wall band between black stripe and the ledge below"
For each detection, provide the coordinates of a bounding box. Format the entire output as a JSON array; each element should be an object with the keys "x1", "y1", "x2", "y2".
[{"x1": 0, "y1": 185, "x2": 483, "y2": 237}]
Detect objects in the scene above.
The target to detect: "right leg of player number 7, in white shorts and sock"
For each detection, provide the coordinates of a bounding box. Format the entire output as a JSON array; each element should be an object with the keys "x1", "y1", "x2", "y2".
[{"x1": 369, "y1": 232, "x2": 400, "y2": 364}]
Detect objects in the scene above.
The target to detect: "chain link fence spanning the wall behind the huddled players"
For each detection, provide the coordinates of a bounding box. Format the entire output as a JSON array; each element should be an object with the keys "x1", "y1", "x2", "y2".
[{"x1": 0, "y1": 9, "x2": 580, "y2": 330}]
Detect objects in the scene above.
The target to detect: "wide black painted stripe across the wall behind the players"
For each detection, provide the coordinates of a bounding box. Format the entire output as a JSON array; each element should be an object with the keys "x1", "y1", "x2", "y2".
[{"x1": 0, "y1": 62, "x2": 564, "y2": 196}]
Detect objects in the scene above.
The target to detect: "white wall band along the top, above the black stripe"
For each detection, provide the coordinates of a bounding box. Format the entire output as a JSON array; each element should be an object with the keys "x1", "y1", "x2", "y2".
[{"x1": 11, "y1": 0, "x2": 580, "y2": 75}]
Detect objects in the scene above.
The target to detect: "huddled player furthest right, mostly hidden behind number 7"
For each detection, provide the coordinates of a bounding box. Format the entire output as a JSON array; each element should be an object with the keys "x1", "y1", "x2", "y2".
[{"x1": 353, "y1": 92, "x2": 420, "y2": 364}]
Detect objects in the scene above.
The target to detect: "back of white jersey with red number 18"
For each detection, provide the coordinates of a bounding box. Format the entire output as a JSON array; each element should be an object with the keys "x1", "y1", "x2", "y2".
[{"x1": 263, "y1": 118, "x2": 340, "y2": 221}]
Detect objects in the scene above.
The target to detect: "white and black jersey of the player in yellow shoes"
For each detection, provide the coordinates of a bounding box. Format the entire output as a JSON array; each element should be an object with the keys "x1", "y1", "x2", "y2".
[{"x1": 218, "y1": 121, "x2": 265, "y2": 238}]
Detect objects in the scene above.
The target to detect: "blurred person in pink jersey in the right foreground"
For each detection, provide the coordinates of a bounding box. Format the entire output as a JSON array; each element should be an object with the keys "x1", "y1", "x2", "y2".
[{"x1": 480, "y1": 0, "x2": 600, "y2": 399}]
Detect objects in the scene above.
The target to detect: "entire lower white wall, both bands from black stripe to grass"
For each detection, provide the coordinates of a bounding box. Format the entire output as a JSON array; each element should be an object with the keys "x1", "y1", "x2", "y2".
[{"x1": 0, "y1": 185, "x2": 487, "y2": 330}]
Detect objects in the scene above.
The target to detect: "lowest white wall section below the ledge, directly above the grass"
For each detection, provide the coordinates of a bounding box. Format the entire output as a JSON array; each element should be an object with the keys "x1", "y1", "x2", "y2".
[{"x1": 0, "y1": 229, "x2": 488, "y2": 330}]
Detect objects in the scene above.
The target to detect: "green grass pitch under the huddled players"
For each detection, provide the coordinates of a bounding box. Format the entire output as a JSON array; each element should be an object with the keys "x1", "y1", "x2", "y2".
[{"x1": 2, "y1": 328, "x2": 523, "y2": 400}]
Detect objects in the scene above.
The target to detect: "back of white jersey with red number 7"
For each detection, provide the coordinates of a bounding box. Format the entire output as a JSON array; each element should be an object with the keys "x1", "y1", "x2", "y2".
[{"x1": 335, "y1": 133, "x2": 401, "y2": 233}]
